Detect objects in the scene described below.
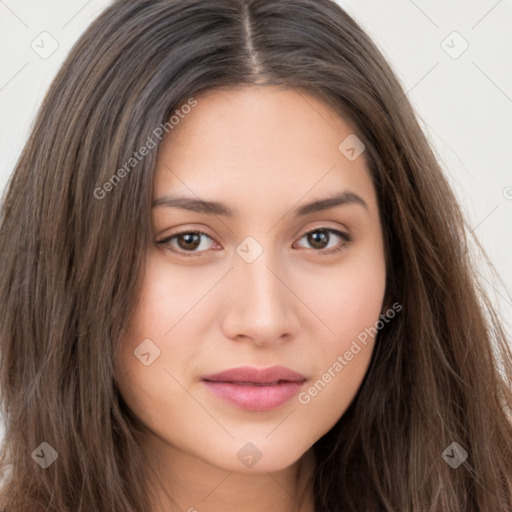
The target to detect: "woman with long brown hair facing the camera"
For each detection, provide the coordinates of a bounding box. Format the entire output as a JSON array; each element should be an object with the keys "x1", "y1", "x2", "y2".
[{"x1": 0, "y1": 0, "x2": 512, "y2": 512}]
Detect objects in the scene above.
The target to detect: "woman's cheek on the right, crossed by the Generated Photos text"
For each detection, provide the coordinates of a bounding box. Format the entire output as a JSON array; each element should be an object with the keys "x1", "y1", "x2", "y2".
[{"x1": 298, "y1": 241, "x2": 386, "y2": 416}]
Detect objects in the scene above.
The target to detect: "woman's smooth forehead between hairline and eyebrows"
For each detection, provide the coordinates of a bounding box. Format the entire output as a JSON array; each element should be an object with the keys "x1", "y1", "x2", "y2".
[{"x1": 154, "y1": 86, "x2": 375, "y2": 218}]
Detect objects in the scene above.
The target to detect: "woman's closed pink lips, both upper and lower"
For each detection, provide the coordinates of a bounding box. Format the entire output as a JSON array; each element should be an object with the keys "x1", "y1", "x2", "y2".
[{"x1": 201, "y1": 366, "x2": 307, "y2": 411}]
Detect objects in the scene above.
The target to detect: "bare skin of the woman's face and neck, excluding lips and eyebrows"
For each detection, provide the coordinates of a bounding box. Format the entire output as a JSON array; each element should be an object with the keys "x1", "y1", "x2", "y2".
[{"x1": 117, "y1": 86, "x2": 386, "y2": 512}]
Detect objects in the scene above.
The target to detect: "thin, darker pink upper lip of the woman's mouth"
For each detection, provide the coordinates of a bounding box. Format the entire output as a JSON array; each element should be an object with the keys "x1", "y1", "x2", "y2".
[{"x1": 202, "y1": 366, "x2": 306, "y2": 384}]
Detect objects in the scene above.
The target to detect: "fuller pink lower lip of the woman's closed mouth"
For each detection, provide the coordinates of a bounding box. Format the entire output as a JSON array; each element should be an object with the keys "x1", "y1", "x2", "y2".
[{"x1": 202, "y1": 380, "x2": 305, "y2": 411}]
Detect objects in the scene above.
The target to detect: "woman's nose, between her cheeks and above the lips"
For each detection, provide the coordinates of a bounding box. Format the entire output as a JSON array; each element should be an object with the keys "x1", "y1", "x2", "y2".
[{"x1": 222, "y1": 252, "x2": 300, "y2": 345}]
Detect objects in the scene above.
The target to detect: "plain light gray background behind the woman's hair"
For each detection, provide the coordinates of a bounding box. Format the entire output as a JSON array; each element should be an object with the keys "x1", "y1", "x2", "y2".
[{"x1": 0, "y1": 0, "x2": 512, "y2": 435}]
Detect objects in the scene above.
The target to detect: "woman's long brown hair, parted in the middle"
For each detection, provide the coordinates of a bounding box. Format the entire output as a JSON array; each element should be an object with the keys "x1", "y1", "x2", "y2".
[{"x1": 0, "y1": 0, "x2": 512, "y2": 512}]
